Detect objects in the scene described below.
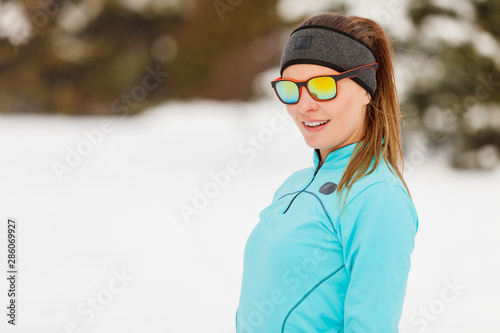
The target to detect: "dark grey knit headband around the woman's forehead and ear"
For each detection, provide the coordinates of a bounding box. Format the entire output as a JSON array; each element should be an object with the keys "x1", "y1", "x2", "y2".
[{"x1": 280, "y1": 25, "x2": 377, "y2": 97}]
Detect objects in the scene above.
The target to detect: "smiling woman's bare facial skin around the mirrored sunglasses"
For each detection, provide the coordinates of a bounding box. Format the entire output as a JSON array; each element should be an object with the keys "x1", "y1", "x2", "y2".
[{"x1": 283, "y1": 64, "x2": 370, "y2": 162}]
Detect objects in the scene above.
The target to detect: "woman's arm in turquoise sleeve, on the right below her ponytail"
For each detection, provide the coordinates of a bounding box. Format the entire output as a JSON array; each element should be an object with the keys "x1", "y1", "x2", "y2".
[{"x1": 338, "y1": 182, "x2": 418, "y2": 333}]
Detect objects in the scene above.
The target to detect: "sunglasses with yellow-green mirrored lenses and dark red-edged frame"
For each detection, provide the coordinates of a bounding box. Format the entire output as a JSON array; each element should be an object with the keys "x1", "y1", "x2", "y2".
[{"x1": 271, "y1": 63, "x2": 378, "y2": 104}]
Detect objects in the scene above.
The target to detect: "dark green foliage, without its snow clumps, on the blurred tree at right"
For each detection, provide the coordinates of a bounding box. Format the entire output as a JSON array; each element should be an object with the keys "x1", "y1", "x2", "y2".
[{"x1": 405, "y1": 0, "x2": 500, "y2": 168}]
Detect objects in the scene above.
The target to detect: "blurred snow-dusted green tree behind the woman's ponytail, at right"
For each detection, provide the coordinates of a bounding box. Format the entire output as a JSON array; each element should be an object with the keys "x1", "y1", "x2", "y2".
[{"x1": 402, "y1": 0, "x2": 500, "y2": 168}]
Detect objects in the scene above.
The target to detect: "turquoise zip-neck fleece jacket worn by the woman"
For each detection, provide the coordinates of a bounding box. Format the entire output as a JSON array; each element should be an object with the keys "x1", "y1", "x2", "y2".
[{"x1": 235, "y1": 143, "x2": 418, "y2": 333}]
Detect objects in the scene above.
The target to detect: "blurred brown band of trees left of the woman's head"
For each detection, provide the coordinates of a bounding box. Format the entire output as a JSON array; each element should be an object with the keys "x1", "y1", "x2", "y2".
[{"x1": 0, "y1": 0, "x2": 282, "y2": 114}]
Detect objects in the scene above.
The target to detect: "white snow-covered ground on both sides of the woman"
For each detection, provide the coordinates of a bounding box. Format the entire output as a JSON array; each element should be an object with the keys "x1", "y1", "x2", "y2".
[{"x1": 0, "y1": 101, "x2": 500, "y2": 333}]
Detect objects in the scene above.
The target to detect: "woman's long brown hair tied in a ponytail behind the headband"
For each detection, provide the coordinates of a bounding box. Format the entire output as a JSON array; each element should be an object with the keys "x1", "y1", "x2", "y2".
[{"x1": 299, "y1": 13, "x2": 411, "y2": 213}]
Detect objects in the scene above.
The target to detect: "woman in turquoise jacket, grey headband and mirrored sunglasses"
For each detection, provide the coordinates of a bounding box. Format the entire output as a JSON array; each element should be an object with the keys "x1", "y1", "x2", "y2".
[{"x1": 236, "y1": 14, "x2": 418, "y2": 333}]
